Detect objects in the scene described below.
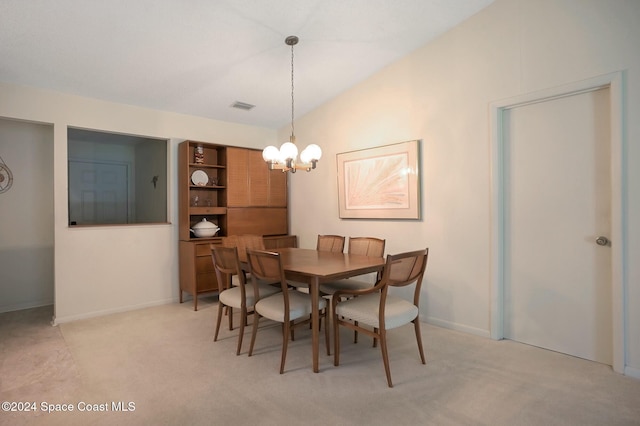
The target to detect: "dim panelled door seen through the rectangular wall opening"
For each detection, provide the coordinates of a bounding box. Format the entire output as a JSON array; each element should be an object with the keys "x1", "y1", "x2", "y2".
[{"x1": 69, "y1": 160, "x2": 129, "y2": 225}]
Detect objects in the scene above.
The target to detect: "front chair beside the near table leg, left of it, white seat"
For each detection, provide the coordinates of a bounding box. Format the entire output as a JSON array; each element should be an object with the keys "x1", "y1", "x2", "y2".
[{"x1": 247, "y1": 250, "x2": 329, "y2": 374}]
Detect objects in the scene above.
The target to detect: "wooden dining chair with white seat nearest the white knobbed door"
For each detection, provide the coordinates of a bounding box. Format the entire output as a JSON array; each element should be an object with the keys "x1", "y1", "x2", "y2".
[{"x1": 331, "y1": 248, "x2": 429, "y2": 388}]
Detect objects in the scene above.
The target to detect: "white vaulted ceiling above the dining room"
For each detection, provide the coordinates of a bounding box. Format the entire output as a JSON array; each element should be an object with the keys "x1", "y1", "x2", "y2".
[{"x1": 0, "y1": 0, "x2": 493, "y2": 128}]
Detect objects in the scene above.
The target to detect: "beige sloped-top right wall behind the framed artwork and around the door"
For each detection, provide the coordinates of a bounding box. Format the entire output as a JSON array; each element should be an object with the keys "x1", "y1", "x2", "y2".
[{"x1": 279, "y1": 0, "x2": 640, "y2": 377}]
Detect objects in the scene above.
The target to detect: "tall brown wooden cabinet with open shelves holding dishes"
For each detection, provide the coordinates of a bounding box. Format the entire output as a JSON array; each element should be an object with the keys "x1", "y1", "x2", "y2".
[{"x1": 178, "y1": 141, "x2": 297, "y2": 310}]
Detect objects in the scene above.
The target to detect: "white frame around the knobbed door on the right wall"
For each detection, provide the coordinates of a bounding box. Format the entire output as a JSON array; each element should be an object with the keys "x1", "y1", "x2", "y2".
[{"x1": 489, "y1": 71, "x2": 627, "y2": 374}]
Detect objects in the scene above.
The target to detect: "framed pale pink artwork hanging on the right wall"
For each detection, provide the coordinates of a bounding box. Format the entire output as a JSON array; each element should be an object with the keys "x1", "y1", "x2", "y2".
[{"x1": 336, "y1": 140, "x2": 420, "y2": 219}]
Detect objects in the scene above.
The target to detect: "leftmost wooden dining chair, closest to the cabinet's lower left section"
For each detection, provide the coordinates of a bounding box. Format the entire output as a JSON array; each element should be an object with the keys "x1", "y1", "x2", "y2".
[{"x1": 211, "y1": 246, "x2": 280, "y2": 355}]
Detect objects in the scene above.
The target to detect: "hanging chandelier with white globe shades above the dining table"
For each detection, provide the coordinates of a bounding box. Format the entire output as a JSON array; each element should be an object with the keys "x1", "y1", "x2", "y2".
[{"x1": 262, "y1": 36, "x2": 322, "y2": 173}]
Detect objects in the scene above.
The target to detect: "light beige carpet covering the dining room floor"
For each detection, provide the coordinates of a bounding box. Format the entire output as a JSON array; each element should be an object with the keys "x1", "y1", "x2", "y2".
[{"x1": 0, "y1": 299, "x2": 640, "y2": 425}]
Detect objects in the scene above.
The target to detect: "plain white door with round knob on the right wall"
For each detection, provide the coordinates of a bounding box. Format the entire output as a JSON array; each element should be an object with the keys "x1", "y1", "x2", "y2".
[{"x1": 502, "y1": 88, "x2": 615, "y2": 364}]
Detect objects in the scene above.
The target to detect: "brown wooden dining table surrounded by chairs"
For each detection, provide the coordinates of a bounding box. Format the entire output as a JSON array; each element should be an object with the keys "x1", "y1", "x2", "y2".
[{"x1": 273, "y1": 248, "x2": 385, "y2": 373}]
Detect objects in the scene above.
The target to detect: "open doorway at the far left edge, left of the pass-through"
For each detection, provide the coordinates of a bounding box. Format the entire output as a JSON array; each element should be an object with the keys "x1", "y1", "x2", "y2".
[{"x1": 0, "y1": 117, "x2": 55, "y2": 312}]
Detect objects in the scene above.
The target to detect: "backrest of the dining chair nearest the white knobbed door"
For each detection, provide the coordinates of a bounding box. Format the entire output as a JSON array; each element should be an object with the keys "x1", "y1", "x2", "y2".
[{"x1": 377, "y1": 248, "x2": 429, "y2": 306}]
